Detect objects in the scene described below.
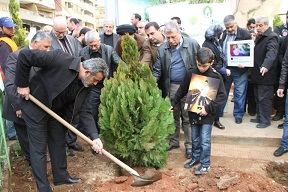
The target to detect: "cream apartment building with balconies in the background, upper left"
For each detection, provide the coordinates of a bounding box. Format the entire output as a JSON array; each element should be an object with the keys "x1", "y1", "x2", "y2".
[{"x1": 0, "y1": 0, "x2": 105, "y2": 31}]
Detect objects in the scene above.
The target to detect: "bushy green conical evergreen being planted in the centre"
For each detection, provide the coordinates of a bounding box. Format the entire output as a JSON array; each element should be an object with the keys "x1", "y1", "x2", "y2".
[{"x1": 99, "y1": 35, "x2": 175, "y2": 167}]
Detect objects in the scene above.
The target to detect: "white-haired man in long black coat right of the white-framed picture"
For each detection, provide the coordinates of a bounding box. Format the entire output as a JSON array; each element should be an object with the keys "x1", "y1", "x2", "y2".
[{"x1": 250, "y1": 16, "x2": 279, "y2": 128}]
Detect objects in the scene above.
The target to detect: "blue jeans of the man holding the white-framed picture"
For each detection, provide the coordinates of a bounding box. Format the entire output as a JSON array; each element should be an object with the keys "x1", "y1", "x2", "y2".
[{"x1": 220, "y1": 69, "x2": 248, "y2": 119}]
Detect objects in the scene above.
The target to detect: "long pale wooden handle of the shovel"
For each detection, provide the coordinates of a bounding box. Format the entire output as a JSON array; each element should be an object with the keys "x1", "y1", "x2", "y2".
[{"x1": 29, "y1": 94, "x2": 140, "y2": 176}]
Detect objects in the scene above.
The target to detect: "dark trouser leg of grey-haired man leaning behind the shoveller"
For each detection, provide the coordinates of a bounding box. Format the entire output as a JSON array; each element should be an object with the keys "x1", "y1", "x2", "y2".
[{"x1": 14, "y1": 122, "x2": 30, "y2": 165}]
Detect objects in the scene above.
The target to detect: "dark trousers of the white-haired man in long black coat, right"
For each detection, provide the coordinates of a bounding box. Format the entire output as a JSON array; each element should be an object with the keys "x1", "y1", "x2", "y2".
[{"x1": 254, "y1": 84, "x2": 274, "y2": 124}]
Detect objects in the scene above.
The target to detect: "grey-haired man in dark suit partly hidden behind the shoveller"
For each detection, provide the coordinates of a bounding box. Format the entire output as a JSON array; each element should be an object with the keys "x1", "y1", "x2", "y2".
[{"x1": 2, "y1": 31, "x2": 51, "y2": 164}]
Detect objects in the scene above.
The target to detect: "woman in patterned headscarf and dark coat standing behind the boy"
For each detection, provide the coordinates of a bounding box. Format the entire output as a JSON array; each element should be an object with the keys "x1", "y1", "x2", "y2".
[{"x1": 202, "y1": 25, "x2": 231, "y2": 129}]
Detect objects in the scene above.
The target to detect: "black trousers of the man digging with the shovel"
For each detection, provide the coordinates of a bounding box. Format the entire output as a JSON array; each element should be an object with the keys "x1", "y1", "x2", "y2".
[{"x1": 22, "y1": 112, "x2": 69, "y2": 192}]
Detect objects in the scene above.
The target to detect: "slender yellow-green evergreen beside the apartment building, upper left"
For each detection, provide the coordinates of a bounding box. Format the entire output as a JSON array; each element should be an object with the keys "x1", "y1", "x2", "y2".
[{"x1": 9, "y1": 0, "x2": 29, "y2": 48}]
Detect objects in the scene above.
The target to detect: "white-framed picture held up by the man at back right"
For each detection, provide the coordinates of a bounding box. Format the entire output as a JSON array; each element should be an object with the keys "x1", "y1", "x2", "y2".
[{"x1": 227, "y1": 40, "x2": 254, "y2": 67}]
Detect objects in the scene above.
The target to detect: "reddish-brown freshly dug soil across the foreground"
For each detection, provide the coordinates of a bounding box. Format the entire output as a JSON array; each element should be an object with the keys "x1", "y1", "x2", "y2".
[{"x1": 3, "y1": 140, "x2": 288, "y2": 192}]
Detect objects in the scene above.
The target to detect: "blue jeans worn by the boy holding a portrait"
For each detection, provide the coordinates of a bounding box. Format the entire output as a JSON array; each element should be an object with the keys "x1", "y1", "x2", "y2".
[{"x1": 191, "y1": 124, "x2": 212, "y2": 167}]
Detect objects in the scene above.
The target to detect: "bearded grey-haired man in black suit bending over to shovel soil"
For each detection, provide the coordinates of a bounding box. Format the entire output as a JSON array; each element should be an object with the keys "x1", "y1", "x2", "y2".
[{"x1": 15, "y1": 50, "x2": 108, "y2": 192}]
